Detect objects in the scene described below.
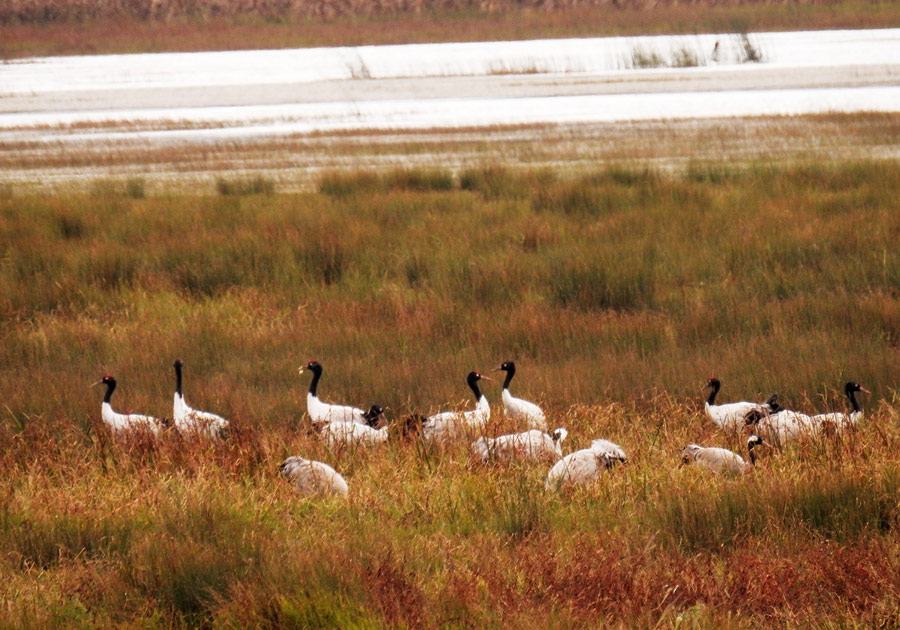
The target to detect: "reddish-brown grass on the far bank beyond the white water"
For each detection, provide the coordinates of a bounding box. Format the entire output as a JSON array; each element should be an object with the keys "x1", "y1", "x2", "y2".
[{"x1": 0, "y1": 0, "x2": 900, "y2": 57}]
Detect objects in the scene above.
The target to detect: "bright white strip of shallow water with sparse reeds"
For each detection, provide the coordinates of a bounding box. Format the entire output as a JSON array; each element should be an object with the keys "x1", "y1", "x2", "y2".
[{"x1": 0, "y1": 29, "x2": 900, "y2": 142}]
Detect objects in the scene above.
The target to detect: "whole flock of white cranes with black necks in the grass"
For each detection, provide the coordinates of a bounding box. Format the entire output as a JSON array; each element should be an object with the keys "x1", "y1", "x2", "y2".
[{"x1": 95, "y1": 359, "x2": 868, "y2": 496}]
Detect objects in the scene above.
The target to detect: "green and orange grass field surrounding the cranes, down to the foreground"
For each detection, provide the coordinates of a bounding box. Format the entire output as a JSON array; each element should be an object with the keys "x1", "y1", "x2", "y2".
[{"x1": 0, "y1": 160, "x2": 900, "y2": 628}]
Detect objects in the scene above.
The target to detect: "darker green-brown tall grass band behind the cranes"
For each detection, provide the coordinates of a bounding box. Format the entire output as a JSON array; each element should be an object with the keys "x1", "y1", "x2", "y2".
[{"x1": 0, "y1": 163, "x2": 900, "y2": 422}]
